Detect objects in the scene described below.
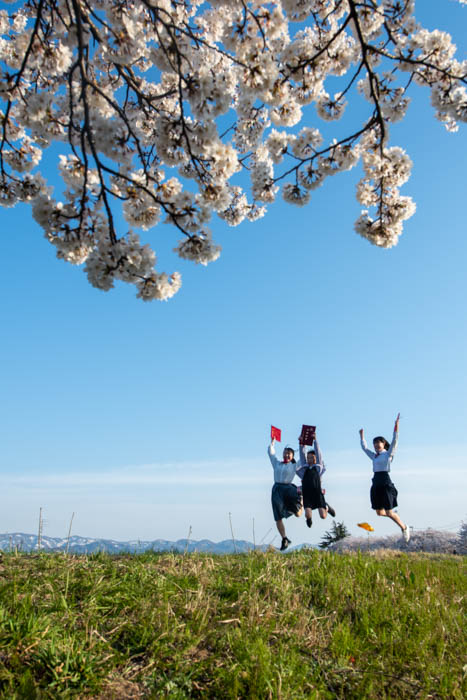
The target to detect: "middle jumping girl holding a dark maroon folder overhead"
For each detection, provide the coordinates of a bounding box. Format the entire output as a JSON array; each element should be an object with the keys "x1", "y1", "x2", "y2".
[{"x1": 297, "y1": 430, "x2": 336, "y2": 527}]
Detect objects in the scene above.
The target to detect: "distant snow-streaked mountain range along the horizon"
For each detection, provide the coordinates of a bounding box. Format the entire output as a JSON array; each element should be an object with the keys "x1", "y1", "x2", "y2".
[{"x1": 0, "y1": 532, "x2": 290, "y2": 554}]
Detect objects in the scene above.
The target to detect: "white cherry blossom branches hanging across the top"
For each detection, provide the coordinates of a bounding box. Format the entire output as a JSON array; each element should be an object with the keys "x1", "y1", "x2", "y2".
[{"x1": 0, "y1": 0, "x2": 467, "y2": 300}]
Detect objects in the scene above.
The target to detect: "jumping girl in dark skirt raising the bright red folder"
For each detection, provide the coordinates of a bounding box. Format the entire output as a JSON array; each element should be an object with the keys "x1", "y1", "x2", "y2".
[{"x1": 268, "y1": 438, "x2": 303, "y2": 552}]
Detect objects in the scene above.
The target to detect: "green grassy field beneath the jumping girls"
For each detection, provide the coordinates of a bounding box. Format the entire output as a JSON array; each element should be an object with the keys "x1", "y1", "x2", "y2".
[{"x1": 0, "y1": 551, "x2": 467, "y2": 700}]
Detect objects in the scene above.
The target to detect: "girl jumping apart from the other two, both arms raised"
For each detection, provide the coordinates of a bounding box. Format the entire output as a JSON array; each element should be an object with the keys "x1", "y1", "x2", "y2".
[{"x1": 359, "y1": 414, "x2": 410, "y2": 542}]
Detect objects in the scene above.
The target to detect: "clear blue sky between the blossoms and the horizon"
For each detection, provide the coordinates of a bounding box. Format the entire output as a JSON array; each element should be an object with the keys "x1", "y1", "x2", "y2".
[{"x1": 0, "y1": 2, "x2": 467, "y2": 543}]
